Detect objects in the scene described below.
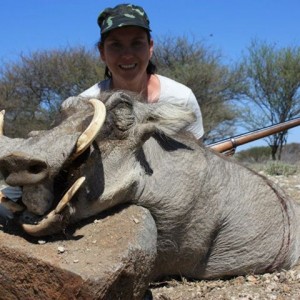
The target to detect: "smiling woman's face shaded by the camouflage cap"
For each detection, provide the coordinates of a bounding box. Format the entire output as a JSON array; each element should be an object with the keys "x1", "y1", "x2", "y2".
[{"x1": 100, "y1": 26, "x2": 153, "y2": 84}]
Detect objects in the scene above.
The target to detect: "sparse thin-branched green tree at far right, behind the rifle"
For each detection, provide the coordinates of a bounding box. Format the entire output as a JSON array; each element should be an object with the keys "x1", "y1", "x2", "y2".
[{"x1": 241, "y1": 41, "x2": 300, "y2": 160}]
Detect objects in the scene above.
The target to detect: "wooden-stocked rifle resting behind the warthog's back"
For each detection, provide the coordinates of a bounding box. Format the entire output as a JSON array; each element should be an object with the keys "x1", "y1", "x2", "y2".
[{"x1": 208, "y1": 118, "x2": 300, "y2": 153}]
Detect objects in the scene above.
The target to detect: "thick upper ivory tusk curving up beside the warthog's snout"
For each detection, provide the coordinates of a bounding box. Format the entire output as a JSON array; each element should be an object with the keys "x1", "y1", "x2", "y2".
[{"x1": 73, "y1": 99, "x2": 106, "y2": 158}]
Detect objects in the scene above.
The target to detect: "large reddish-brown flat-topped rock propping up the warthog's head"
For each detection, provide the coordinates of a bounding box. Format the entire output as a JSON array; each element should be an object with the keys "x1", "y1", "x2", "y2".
[{"x1": 0, "y1": 205, "x2": 157, "y2": 300}]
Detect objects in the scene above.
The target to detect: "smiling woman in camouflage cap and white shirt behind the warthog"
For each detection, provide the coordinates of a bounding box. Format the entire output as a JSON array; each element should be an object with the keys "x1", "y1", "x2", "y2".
[{"x1": 81, "y1": 4, "x2": 204, "y2": 139}]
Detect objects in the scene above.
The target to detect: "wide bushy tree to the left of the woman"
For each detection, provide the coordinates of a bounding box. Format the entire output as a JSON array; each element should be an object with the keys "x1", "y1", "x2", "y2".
[{"x1": 0, "y1": 47, "x2": 104, "y2": 136}]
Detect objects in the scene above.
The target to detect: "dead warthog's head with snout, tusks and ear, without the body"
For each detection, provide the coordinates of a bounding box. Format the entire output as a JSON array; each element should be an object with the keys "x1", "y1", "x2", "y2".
[{"x1": 0, "y1": 92, "x2": 194, "y2": 236}]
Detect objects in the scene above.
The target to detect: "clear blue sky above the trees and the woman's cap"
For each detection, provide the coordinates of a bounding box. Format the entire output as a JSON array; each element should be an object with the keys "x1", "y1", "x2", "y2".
[{"x1": 0, "y1": 0, "x2": 300, "y2": 148}]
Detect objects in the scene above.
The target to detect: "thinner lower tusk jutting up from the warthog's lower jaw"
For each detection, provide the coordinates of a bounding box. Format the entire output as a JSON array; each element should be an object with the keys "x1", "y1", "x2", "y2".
[{"x1": 21, "y1": 177, "x2": 85, "y2": 236}]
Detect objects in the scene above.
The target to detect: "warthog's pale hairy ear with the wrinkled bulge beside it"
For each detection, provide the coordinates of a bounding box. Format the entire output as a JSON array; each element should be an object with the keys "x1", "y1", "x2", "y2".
[{"x1": 106, "y1": 91, "x2": 196, "y2": 146}]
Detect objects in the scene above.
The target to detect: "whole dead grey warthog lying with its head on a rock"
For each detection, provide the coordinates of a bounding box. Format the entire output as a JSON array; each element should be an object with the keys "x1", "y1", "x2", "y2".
[{"x1": 0, "y1": 91, "x2": 300, "y2": 279}]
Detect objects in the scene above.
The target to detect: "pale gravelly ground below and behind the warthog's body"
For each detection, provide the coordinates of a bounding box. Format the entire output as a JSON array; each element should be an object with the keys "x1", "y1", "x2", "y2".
[{"x1": 151, "y1": 172, "x2": 300, "y2": 300}]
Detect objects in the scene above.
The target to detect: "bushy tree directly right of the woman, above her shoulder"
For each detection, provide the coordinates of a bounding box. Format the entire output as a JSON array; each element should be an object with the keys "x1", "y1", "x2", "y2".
[{"x1": 154, "y1": 36, "x2": 244, "y2": 142}]
